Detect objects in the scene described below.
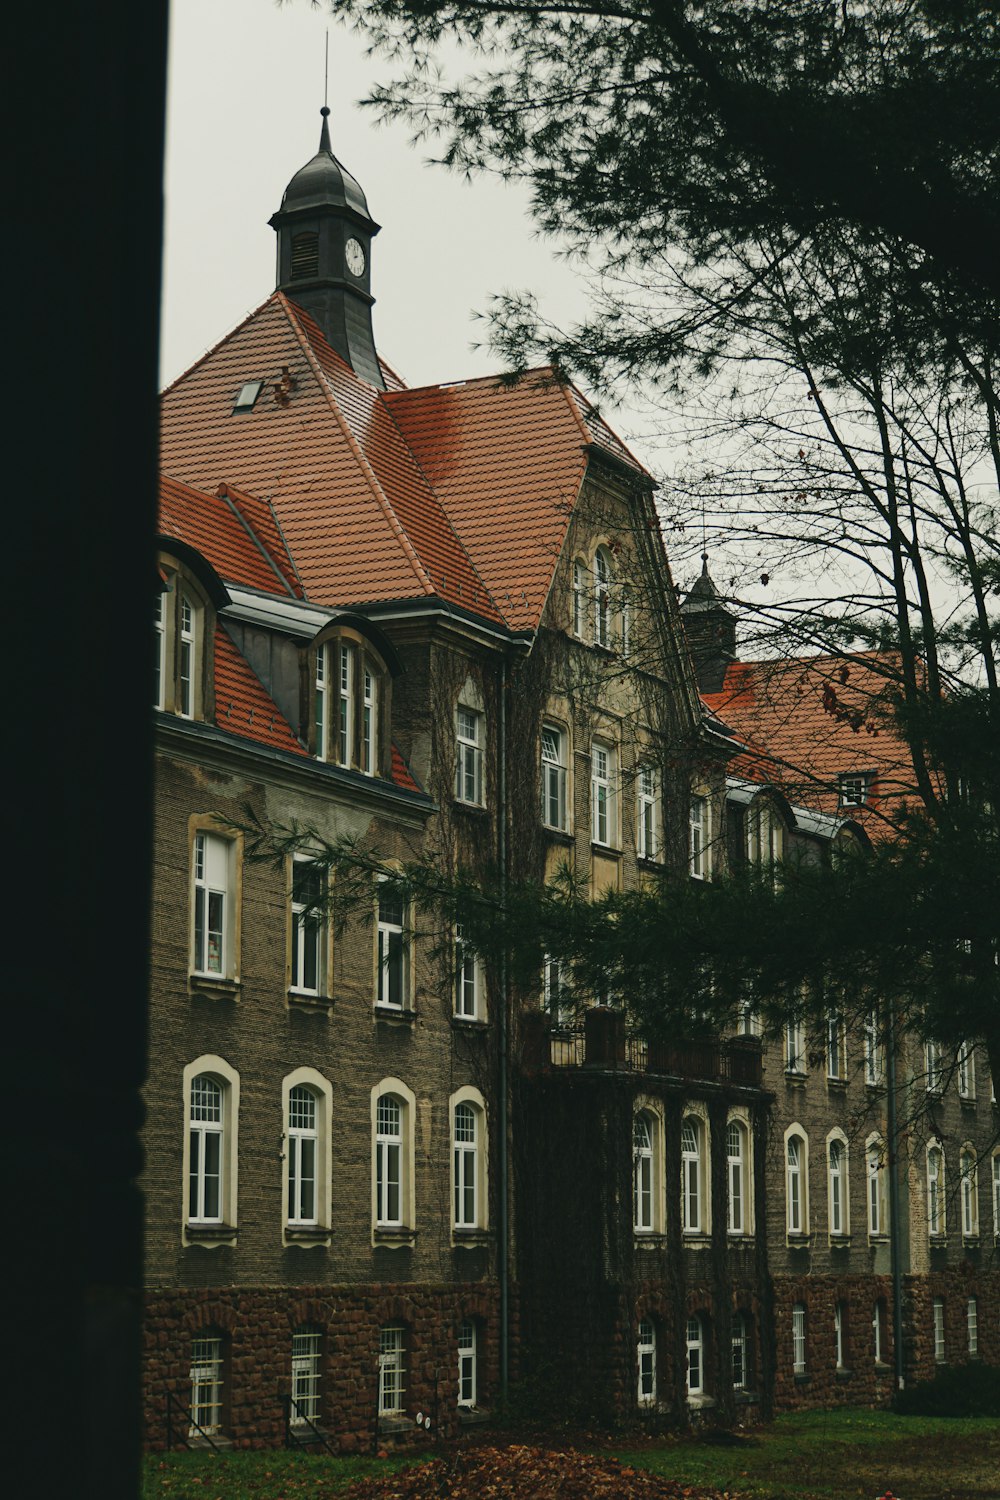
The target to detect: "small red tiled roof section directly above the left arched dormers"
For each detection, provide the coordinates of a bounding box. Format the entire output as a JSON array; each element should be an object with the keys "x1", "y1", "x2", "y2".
[{"x1": 159, "y1": 474, "x2": 294, "y2": 594}]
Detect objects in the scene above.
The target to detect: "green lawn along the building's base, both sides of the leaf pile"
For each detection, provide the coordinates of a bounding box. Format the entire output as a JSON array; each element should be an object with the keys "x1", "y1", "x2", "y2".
[{"x1": 142, "y1": 1410, "x2": 1000, "y2": 1500}]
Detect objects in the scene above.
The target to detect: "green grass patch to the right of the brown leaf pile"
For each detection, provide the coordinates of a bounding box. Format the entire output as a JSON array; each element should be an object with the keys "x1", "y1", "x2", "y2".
[{"x1": 615, "y1": 1409, "x2": 1000, "y2": 1500}]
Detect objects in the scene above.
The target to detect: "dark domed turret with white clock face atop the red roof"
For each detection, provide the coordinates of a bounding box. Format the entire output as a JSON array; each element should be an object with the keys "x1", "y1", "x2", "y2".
[{"x1": 268, "y1": 105, "x2": 385, "y2": 390}]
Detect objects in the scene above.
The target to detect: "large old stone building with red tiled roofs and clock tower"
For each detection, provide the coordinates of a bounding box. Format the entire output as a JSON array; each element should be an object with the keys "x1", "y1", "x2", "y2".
[{"x1": 144, "y1": 111, "x2": 1000, "y2": 1449}]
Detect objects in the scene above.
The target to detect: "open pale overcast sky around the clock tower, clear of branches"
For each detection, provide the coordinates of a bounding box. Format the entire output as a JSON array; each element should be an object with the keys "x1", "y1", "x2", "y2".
[{"x1": 160, "y1": 0, "x2": 617, "y2": 411}]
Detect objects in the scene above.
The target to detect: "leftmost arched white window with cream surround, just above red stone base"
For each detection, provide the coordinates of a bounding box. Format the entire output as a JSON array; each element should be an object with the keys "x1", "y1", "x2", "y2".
[{"x1": 183, "y1": 1055, "x2": 240, "y2": 1242}]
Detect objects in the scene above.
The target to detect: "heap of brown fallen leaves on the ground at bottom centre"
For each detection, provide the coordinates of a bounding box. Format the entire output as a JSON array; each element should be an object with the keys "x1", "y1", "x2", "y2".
[{"x1": 345, "y1": 1446, "x2": 738, "y2": 1500}]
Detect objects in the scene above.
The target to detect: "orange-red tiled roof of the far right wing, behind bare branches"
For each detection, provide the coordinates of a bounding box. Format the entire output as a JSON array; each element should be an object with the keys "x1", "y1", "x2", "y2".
[{"x1": 703, "y1": 651, "x2": 913, "y2": 839}]
